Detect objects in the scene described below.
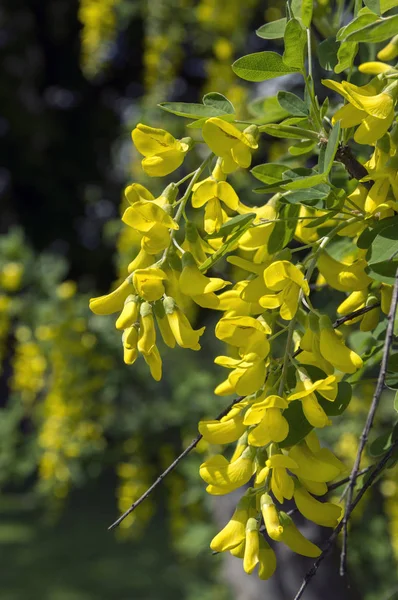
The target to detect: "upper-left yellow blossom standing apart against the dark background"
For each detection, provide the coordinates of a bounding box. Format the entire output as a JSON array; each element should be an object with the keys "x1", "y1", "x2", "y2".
[{"x1": 131, "y1": 123, "x2": 192, "y2": 177}]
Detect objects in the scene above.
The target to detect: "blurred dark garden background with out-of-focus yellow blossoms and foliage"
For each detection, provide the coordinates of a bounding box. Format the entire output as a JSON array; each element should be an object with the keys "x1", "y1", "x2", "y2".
[{"x1": 0, "y1": 0, "x2": 398, "y2": 600}]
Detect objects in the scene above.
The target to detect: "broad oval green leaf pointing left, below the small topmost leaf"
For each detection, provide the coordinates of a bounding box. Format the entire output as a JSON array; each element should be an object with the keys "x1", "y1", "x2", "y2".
[{"x1": 232, "y1": 52, "x2": 300, "y2": 81}]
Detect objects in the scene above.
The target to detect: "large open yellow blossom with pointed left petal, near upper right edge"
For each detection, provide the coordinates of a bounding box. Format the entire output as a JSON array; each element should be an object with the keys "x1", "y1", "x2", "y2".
[{"x1": 322, "y1": 77, "x2": 398, "y2": 144}]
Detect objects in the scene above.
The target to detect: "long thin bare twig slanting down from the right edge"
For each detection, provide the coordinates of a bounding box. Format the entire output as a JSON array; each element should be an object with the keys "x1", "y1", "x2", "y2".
[{"x1": 340, "y1": 269, "x2": 398, "y2": 576}]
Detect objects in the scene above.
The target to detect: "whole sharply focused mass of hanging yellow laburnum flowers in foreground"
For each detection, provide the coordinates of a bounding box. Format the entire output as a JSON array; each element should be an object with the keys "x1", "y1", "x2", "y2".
[{"x1": 90, "y1": 21, "x2": 398, "y2": 579}]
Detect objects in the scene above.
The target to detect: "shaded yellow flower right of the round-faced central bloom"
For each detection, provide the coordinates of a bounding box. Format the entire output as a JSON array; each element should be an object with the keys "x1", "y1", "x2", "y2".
[{"x1": 317, "y1": 250, "x2": 372, "y2": 292}]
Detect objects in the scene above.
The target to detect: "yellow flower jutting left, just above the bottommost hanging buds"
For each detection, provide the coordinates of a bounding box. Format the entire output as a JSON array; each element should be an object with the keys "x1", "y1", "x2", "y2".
[{"x1": 199, "y1": 448, "x2": 255, "y2": 494}]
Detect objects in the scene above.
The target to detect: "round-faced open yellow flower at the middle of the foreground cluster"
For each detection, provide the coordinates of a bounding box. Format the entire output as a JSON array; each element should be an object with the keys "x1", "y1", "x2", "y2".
[{"x1": 259, "y1": 260, "x2": 310, "y2": 321}]
